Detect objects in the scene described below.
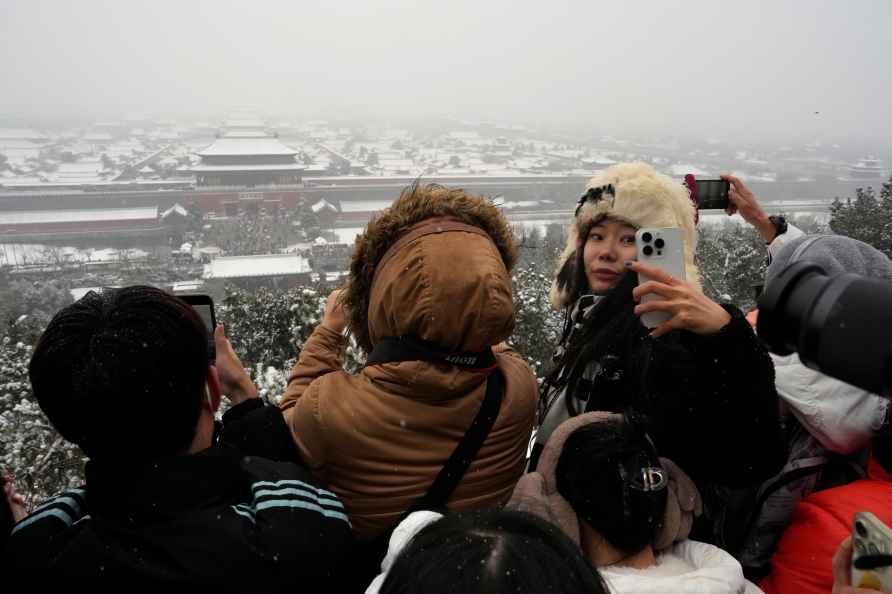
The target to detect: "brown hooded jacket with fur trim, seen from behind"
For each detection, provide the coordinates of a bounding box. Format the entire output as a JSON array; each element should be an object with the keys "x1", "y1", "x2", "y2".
[{"x1": 281, "y1": 186, "x2": 537, "y2": 538}]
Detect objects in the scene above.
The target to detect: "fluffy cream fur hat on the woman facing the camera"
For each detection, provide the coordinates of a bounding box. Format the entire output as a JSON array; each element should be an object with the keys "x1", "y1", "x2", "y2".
[{"x1": 551, "y1": 163, "x2": 700, "y2": 309}]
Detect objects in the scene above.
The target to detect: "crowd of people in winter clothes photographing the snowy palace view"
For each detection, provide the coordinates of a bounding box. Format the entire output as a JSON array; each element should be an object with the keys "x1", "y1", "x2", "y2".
[{"x1": 2, "y1": 163, "x2": 892, "y2": 594}]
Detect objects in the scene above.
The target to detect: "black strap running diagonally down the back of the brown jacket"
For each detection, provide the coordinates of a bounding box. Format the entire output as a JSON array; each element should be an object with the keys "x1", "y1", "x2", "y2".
[{"x1": 403, "y1": 369, "x2": 505, "y2": 518}]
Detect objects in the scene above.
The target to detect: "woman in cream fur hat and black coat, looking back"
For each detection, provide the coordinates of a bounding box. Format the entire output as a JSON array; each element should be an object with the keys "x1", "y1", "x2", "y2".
[{"x1": 531, "y1": 163, "x2": 784, "y2": 504}]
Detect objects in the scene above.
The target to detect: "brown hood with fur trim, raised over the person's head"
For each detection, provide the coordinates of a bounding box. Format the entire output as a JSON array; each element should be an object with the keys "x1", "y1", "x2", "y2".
[{"x1": 343, "y1": 184, "x2": 517, "y2": 353}]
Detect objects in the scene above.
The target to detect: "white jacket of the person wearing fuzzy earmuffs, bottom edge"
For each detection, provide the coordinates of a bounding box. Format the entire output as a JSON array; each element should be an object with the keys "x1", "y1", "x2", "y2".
[{"x1": 599, "y1": 540, "x2": 762, "y2": 594}]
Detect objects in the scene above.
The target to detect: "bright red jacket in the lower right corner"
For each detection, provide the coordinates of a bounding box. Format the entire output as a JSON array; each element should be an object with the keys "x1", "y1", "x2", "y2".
[{"x1": 759, "y1": 458, "x2": 892, "y2": 594}]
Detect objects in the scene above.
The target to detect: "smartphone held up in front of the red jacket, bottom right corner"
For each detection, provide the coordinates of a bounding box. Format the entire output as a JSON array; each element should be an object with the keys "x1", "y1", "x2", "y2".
[{"x1": 852, "y1": 512, "x2": 892, "y2": 592}]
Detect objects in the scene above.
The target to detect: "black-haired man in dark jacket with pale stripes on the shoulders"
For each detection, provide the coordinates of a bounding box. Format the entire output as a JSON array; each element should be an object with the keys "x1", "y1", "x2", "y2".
[{"x1": 7, "y1": 286, "x2": 351, "y2": 590}]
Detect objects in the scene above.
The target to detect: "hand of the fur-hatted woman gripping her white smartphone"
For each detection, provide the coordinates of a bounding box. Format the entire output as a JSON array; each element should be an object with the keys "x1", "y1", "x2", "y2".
[{"x1": 628, "y1": 262, "x2": 731, "y2": 338}]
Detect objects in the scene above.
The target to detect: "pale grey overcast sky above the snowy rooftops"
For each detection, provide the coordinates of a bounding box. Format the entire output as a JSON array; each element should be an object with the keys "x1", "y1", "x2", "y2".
[{"x1": 0, "y1": 0, "x2": 892, "y2": 141}]
